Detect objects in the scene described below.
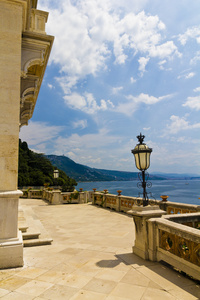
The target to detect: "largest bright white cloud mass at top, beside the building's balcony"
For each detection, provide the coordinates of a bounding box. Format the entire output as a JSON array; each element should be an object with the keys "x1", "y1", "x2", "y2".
[{"x1": 40, "y1": 0, "x2": 180, "y2": 93}]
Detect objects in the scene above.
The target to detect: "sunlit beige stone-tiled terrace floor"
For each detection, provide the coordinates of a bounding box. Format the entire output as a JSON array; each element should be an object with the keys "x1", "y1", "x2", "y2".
[{"x1": 0, "y1": 199, "x2": 200, "y2": 300}]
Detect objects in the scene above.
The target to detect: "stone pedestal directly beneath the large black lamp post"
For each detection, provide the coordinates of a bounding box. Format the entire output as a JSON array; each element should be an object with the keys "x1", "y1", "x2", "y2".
[{"x1": 128, "y1": 206, "x2": 166, "y2": 259}]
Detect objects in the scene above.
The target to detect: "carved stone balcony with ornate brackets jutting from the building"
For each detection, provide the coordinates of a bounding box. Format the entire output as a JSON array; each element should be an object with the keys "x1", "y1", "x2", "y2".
[{"x1": 20, "y1": 32, "x2": 53, "y2": 127}]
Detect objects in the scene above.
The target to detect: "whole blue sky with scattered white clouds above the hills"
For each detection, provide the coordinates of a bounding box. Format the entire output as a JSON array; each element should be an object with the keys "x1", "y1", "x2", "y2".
[{"x1": 20, "y1": 0, "x2": 200, "y2": 174}]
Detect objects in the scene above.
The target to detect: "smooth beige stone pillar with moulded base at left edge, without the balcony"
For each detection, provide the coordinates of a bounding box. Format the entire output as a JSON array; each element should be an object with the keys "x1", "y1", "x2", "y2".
[{"x1": 0, "y1": 0, "x2": 25, "y2": 268}]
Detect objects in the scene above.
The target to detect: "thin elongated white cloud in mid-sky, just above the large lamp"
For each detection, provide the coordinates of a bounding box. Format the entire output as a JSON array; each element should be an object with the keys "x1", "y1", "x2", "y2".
[{"x1": 115, "y1": 93, "x2": 172, "y2": 116}]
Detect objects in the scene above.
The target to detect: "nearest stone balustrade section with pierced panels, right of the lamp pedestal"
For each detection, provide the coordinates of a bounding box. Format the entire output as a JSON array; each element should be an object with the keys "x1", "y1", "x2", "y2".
[{"x1": 146, "y1": 213, "x2": 200, "y2": 280}]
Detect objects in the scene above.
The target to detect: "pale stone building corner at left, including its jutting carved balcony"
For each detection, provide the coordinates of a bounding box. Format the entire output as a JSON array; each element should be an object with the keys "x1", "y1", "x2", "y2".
[{"x1": 0, "y1": 0, "x2": 54, "y2": 268}]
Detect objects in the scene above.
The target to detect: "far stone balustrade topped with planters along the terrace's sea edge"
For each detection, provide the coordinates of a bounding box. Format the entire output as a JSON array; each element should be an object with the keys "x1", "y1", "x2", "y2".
[{"x1": 22, "y1": 188, "x2": 200, "y2": 214}]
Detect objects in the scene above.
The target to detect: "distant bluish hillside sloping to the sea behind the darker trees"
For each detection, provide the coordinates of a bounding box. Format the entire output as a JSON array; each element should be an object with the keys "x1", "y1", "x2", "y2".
[{"x1": 46, "y1": 155, "x2": 166, "y2": 182}]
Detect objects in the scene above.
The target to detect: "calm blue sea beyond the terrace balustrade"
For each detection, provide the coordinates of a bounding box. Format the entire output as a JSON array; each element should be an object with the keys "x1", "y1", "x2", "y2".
[{"x1": 76, "y1": 180, "x2": 200, "y2": 205}]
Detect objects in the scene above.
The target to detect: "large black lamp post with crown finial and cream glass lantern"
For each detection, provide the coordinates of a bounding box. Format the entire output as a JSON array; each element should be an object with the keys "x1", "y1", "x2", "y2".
[{"x1": 131, "y1": 133, "x2": 152, "y2": 206}]
